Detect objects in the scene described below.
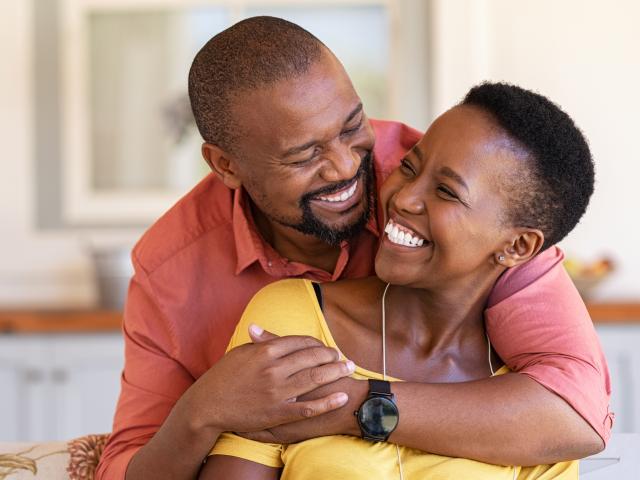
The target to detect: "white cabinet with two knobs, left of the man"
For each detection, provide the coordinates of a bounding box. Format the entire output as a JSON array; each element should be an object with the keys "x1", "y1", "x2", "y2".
[{"x1": 0, "y1": 333, "x2": 124, "y2": 441}]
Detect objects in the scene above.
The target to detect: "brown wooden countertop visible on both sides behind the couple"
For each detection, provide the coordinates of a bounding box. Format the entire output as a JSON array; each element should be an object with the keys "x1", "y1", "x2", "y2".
[{"x1": 0, "y1": 302, "x2": 640, "y2": 334}]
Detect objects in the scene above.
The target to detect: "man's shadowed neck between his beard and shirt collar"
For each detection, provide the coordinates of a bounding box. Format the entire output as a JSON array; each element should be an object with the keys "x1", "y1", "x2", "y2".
[{"x1": 251, "y1": 205, "x2": 340, "y2": 272}]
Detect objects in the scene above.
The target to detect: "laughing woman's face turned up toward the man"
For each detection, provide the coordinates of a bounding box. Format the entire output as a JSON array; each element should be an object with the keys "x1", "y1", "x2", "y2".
[{"x1": 376, "y1": 106, "x2": 523, "y2": 288}]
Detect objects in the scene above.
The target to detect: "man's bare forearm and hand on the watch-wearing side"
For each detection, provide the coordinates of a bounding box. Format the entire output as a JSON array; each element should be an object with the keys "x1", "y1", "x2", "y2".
[{"x1": 243, "y1": 333, "x2": 603, "y2": 466}]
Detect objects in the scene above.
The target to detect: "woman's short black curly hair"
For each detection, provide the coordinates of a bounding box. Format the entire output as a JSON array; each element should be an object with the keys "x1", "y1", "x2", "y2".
[{"x1": 462, "y1": 83, "x2": 594, "y2": 250}]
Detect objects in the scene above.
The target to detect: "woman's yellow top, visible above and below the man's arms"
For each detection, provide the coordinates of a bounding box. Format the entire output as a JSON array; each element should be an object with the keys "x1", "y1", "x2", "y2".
[{"x1": 210, "y1": 279, "x2": 578, "y2": 480}]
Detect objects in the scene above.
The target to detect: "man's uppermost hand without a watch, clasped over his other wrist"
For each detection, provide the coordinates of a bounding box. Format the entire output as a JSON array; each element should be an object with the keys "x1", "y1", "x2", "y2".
[{"x1": 178, "y1": 325, "x2": 354, "y2": 432}]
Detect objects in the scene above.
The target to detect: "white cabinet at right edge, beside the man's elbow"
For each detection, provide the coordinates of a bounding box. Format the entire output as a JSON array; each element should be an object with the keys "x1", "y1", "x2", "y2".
[{"x1": 596, "y1": 323, "x2": 640, "y2": 433}]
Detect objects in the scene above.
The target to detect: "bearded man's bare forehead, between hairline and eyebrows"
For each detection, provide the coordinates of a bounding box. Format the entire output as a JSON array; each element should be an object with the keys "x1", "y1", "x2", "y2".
[{"x1": 231, "y1": 53, "x2": 360, "y2": 151}]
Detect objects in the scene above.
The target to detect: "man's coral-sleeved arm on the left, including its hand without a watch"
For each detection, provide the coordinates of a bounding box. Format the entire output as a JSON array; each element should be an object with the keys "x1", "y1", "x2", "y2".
[{"x1": 97, "y1": 269, "x2": 356, "y2": 480}]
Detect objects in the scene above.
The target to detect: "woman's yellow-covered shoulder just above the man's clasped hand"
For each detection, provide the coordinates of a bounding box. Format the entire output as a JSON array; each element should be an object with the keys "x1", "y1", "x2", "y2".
[{"x1": 229, "y1": 279, "x2": 324, "y2": 348}]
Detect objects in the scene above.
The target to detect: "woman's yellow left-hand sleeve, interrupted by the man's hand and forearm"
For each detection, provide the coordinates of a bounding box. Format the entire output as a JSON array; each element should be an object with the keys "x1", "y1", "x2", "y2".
[{"x1": 209, "y1": 279, "x2": 326, "y2": 468}]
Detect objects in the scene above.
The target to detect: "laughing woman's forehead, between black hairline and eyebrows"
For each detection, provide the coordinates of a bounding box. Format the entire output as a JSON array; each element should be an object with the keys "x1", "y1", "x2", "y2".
[{"x1": 418, "y1": 105, "x2": 522, "y2": 179}]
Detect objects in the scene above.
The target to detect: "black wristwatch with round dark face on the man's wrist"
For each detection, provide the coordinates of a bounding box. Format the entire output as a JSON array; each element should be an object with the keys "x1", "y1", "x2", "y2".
[{"x1": 353, "y1": 380, "x2": 400, "y2": 442}]
